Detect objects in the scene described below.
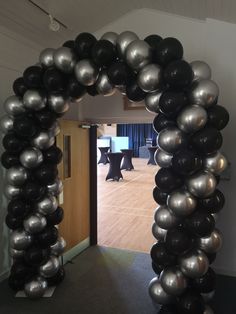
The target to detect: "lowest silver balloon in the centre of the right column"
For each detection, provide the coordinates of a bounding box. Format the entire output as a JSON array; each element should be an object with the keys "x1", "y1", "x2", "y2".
[{"x1": 179, "y1": 250, "x2": 209, "y2": 278}]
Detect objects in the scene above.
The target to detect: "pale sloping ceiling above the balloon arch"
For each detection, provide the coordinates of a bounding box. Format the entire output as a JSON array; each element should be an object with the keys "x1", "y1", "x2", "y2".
[{"x1": 0, "y1": 0, "x2": 236, "y2": 47}]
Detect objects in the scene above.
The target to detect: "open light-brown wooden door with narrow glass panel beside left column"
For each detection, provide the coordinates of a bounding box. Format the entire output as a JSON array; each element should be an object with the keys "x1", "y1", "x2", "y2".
[{"x1": 57, "y1": 120, "x2": 90, "y2": 258}]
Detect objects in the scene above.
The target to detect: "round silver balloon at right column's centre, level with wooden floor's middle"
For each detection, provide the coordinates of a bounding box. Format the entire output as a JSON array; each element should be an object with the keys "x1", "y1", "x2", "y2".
[{"x1": 167, "y1": 189, "x2": 197, "y2": 217}]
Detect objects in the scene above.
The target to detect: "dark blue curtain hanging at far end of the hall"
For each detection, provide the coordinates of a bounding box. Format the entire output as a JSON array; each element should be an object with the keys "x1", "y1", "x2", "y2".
[{"x1": 117, "y1": 123, "x2": 157, "y2": 157}]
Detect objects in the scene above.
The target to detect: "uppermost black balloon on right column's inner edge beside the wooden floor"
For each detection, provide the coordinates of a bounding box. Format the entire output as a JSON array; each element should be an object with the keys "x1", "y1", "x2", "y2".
[{"x1": 155, "y1": 168, "x2": 183, "y2": 193}]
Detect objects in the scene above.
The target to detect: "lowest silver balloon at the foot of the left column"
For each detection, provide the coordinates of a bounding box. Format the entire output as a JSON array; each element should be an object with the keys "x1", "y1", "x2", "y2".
[{"x1": 24, "y1": 278, "x2": 47, "y2": 299}]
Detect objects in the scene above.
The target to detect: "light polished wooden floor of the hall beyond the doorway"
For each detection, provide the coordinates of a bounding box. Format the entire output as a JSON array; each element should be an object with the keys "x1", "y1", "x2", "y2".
[{"x1": 98, "y1": 158, "x2": 158, "y2": 252}]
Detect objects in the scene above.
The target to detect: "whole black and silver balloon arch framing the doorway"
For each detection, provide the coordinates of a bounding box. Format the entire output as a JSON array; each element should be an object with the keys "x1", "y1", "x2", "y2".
[{"x1": 0, "y1": 31, "x2": 229, "y2": 314}]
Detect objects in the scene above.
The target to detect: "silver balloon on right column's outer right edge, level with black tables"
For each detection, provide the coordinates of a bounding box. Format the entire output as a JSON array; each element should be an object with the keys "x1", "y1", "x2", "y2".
[{"x1": 203, "y1": 152, "x2": 228, "y2": 175}]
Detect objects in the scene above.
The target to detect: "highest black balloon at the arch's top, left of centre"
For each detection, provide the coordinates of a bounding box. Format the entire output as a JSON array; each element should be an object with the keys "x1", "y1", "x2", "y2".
[{"x1": 75, "y1": 33, "x2": 97, "y2": 59}]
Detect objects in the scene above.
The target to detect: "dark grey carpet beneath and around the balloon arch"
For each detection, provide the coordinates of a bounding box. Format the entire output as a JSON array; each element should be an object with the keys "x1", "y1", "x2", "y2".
[{"x1": 0, "y1": 246, "x2": 236, "y2": 314}]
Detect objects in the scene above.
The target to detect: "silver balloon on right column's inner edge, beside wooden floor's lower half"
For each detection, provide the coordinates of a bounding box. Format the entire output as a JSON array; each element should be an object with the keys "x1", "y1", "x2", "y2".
[{"x1": 154, "y1": 205, "x2": 180, "y2": 230}]
